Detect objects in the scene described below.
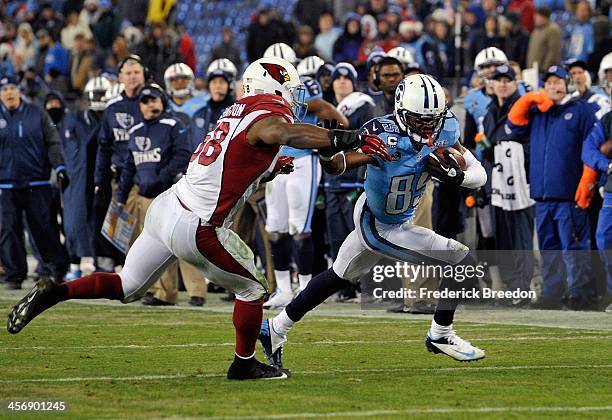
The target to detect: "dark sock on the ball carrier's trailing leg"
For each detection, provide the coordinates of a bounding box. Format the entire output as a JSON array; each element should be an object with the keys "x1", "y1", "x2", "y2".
[{"x1": 285, "y1": 268, "x2": 352, "y2": 322}]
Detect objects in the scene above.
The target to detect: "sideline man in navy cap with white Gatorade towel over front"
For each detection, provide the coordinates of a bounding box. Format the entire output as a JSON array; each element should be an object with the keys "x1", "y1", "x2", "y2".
[{"x1": 483, "y1": 65, "x2": 534, "y2": 307}]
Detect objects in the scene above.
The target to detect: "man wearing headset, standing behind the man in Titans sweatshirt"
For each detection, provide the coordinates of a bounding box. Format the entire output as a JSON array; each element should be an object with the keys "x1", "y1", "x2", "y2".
[{"x1": 94, "y1": 55, "x2": 148, "y2": 272}]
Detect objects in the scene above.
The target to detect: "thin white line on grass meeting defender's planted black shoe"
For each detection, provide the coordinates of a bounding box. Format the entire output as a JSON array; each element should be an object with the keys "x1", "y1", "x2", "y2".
[{"x1": 0, "y1": 365, "x2": 612, "y2": 384}]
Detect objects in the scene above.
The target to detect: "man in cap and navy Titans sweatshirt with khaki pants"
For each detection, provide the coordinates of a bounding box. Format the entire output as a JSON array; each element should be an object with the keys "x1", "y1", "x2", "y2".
[{"x1": 117, "y1": 83, "x2": 191, "y2": 306}]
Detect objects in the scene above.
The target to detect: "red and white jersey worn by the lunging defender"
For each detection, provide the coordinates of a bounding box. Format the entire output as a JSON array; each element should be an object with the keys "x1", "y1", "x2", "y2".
[{"x1": 175, "y1": 95, "x2": 293, "y2": 226}]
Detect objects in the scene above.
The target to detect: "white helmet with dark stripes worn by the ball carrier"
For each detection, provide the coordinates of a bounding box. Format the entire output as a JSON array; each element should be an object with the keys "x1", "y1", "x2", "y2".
[{"x1": 395, "y1": 74, "x2": 447, "y2": 146}]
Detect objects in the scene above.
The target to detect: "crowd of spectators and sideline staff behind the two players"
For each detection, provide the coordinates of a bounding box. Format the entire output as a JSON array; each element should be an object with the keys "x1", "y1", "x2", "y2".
[{"x1": 0, "y1": 0, "x2": 612, "y2": 313}]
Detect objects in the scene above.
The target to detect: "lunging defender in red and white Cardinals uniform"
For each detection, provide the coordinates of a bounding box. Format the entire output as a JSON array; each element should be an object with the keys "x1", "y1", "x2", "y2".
[{"x1": 7, "y1": 58, "x2": 391, "y2": 379}]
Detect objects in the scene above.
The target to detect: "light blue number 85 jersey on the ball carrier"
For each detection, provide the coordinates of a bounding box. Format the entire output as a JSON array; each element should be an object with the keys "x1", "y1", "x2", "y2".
[{"x1": 361, "y1": 111, "x2": 461, "y2": 224}]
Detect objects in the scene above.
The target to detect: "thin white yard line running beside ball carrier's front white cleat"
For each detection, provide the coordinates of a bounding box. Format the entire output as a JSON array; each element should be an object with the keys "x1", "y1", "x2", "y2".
[{"x1": 0, "y1": 335, "x2": 612, "y2": 351}]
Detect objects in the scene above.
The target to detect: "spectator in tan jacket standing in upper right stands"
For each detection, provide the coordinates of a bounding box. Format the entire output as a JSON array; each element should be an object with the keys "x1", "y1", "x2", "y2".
[{"x1": 527, "y1": 7, "x2": 561, "y2": 73}]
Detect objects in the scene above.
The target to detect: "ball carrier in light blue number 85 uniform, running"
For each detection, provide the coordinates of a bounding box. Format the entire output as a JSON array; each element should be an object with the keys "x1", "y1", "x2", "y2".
[{"x1": 259, "y1": 75, "x2": 486, "y2": 366}]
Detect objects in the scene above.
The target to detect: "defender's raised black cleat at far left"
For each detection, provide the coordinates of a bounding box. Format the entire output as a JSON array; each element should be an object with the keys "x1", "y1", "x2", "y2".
[{"x1": 6, "y1": 277, "x2": 65, "y2": 334}]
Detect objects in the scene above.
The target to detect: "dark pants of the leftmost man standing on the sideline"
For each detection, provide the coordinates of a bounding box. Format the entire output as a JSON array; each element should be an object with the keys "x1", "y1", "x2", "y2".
[{"x1": 0, "y1": 185, "x2": 68, "y2": 282}]
